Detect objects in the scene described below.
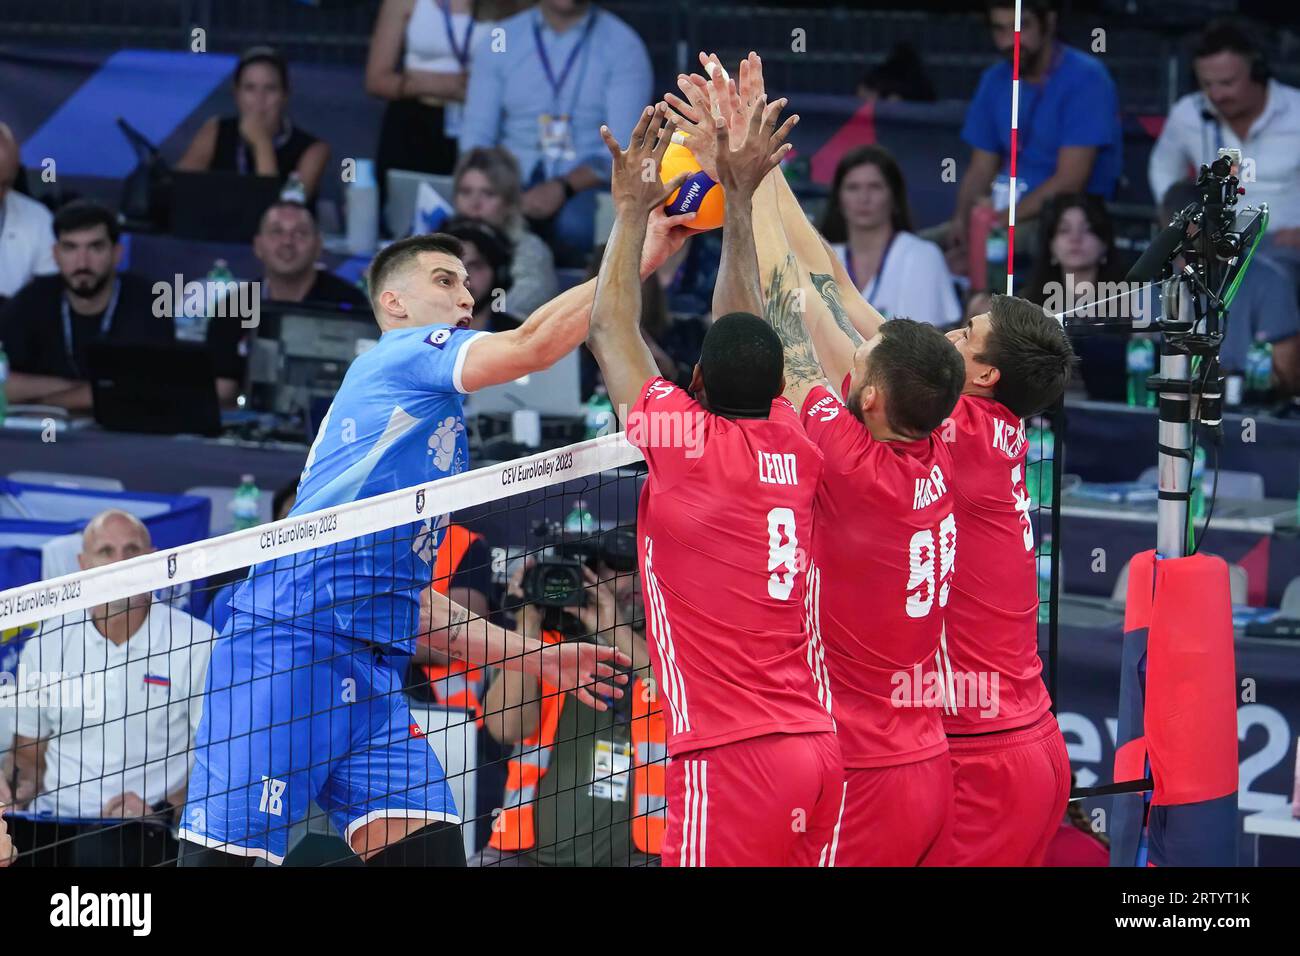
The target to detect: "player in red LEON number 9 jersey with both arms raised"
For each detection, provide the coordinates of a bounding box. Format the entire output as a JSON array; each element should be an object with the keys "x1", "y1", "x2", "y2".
[{"x1": 588, "y1": 101, "x2": 842, "y2": 866}]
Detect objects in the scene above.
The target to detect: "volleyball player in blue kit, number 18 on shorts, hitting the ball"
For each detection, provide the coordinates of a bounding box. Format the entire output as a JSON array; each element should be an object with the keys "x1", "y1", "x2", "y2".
[{"x1": 179, "y1": 191, "x2": 685, "y2": 865}]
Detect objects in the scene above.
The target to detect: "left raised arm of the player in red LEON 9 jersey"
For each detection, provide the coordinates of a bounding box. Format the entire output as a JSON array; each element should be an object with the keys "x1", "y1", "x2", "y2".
[{"x1": 586, "y1": 104, "x2": 685, "y2": 424}]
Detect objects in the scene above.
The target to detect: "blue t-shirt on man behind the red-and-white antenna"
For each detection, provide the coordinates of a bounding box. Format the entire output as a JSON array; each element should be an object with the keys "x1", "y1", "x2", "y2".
[{"x1": 962, "y1": 44, "x2": 1123, "y2": 199}]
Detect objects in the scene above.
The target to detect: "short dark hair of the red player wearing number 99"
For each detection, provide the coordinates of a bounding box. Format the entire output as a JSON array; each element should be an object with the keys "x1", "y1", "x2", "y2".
[{"x1": 866, "y1": 319, "x2": 966, "y2": 437}]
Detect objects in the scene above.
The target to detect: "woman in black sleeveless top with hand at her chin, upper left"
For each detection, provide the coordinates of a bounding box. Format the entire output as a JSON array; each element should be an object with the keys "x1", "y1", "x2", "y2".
[{"x1": 177, "y1": 47, "x2": 329, "y2": 199}]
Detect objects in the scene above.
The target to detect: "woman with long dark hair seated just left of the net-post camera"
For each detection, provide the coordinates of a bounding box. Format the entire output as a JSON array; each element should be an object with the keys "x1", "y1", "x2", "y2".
[{"x1": 1022, "y1": 193, "x2": 1140, "y2": 402}]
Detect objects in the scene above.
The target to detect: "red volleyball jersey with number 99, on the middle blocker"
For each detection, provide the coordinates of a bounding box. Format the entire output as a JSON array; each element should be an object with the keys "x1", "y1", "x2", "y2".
[{"x1": 802, "y1": 386, "x2": 965, "y2": 769}]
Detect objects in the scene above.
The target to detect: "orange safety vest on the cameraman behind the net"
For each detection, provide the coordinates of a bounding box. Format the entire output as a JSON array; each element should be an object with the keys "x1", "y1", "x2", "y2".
[{"x1": 489, "y1": 631, "x2": 668, "y2": 856}]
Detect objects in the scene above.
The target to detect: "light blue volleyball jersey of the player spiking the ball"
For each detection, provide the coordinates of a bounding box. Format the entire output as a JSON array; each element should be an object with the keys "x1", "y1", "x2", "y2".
[{"x1": 233, "y1": 325, "x2": 488, "y2": 654}]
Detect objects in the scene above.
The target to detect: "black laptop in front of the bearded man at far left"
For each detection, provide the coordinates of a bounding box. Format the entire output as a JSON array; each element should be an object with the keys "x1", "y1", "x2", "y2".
[{"x1": 90, "y1": 342, "x2": 221, "y2": 436}]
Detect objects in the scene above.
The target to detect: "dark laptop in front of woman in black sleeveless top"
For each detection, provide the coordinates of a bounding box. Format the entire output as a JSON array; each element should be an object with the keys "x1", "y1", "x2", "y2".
[{"x1": 170, "y1": 172, "x2": 281, "y2": 243}]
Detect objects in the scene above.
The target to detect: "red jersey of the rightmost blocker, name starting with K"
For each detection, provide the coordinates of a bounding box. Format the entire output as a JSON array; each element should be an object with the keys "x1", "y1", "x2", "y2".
[{"x1": 939, "y1": 395, "x2": 1052, "y2": 734}]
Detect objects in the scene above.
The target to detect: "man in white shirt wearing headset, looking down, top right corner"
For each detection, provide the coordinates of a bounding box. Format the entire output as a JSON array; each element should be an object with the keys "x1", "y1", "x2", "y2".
[{"x1": 1147, "y1": 20, "x2": 1300, "y2": 273}]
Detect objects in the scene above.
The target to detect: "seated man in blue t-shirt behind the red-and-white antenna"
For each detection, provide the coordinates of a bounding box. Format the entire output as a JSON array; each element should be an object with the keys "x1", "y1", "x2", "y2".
[{"x1": 948, "y1": 0, "x2": 1123, "y2": 272}]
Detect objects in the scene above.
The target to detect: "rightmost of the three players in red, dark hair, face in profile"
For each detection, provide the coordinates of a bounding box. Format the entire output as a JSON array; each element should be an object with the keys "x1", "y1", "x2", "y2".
[{"x1": 941, "y1": 295, "x2": 1074, "y2": 866}]
